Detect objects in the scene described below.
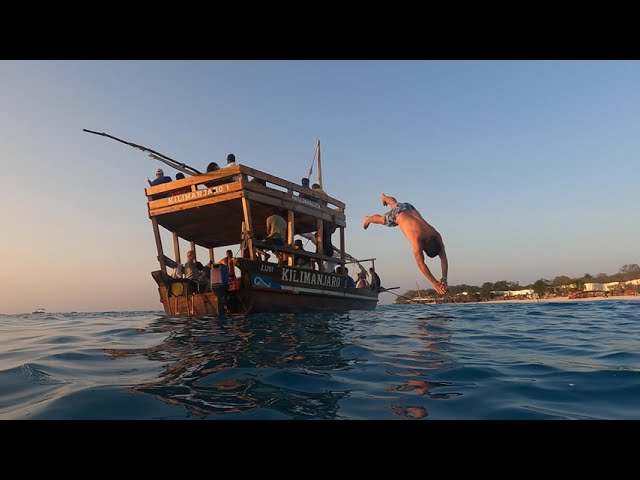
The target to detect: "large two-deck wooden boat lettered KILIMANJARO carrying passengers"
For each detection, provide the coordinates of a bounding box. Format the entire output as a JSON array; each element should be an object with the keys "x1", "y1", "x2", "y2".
[{"x1": 145, "y1": 165, "x2": 378, "y2": 316}]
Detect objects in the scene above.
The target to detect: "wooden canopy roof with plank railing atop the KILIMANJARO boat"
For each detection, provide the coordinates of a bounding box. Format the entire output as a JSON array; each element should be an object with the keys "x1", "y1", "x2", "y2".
[{"x1": 145, "y1": 165, "x2": 346, "y2": 248}]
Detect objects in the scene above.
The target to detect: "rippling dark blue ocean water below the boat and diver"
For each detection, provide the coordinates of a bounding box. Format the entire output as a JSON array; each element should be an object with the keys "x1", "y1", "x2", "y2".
[{"x1": 0, "y1": 300, "x2": 640, "y2": 421}]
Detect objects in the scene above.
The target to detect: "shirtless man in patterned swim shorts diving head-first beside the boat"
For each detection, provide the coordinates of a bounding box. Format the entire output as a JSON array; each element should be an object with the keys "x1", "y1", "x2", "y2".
[{"x1": 363, "y1": 193, "x2": 449, "y2": 295}]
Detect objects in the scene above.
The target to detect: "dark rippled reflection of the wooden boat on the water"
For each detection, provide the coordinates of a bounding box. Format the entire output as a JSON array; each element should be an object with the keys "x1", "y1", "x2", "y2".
[{"x1": 106, "y1": 314, "x2": 350, "y2": 419}]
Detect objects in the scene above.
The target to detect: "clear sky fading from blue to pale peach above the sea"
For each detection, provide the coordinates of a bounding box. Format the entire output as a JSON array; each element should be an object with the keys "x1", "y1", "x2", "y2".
[{"x1": 0, "y1": 60, "x2": 640, "y2": 314}]
